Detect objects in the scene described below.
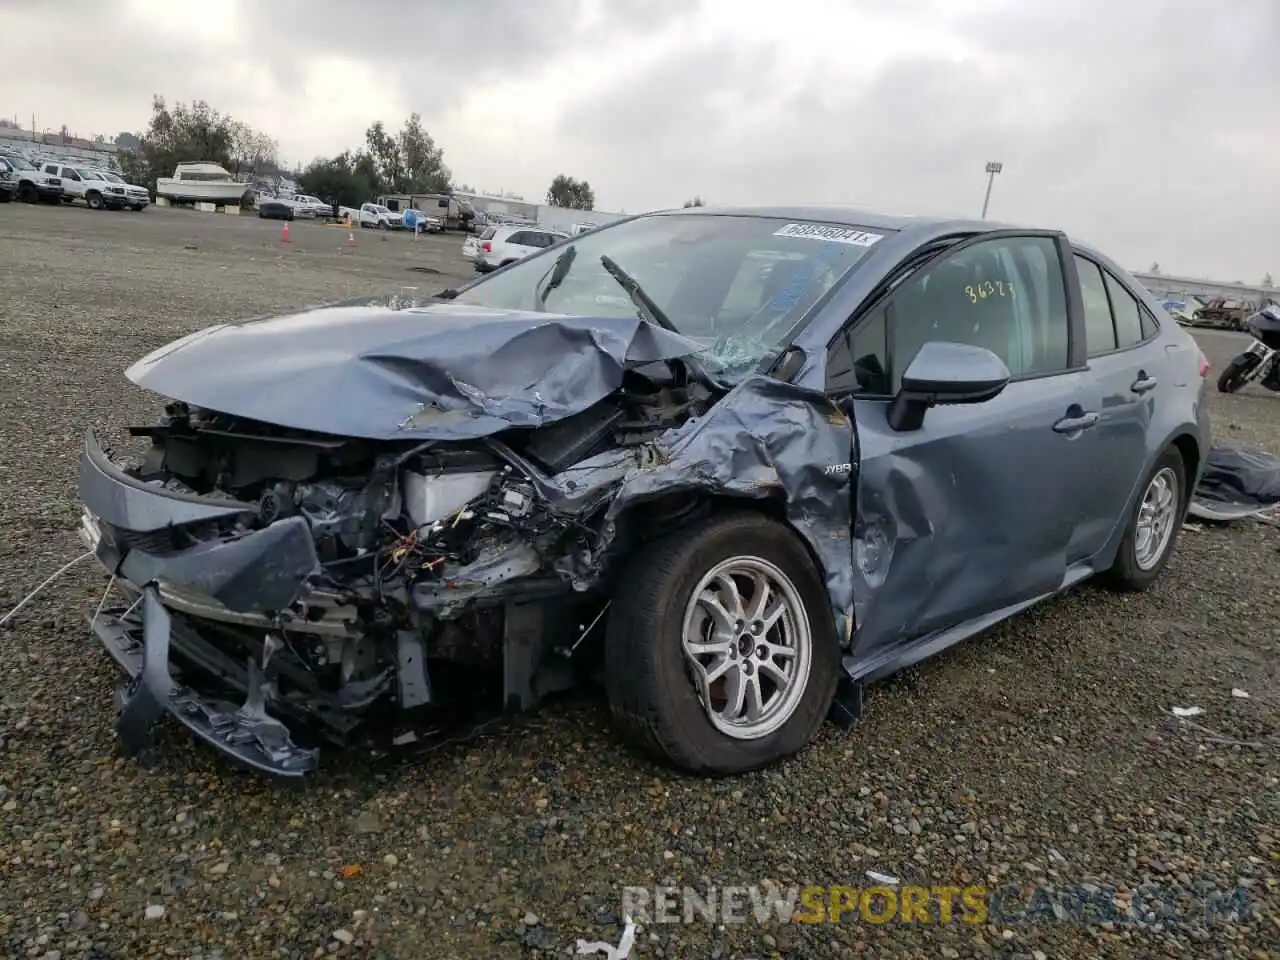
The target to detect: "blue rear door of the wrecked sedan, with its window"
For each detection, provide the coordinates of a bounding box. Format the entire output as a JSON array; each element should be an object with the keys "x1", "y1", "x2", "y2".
[{"x1": 1068, "y1": 253, "x2": 1172, "y2": 563}]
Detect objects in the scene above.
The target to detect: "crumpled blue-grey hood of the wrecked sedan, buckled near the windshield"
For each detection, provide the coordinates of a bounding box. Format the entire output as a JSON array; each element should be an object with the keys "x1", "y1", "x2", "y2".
[{"x1": 125, "y1": 297, "x2": 704, "y2": 440}]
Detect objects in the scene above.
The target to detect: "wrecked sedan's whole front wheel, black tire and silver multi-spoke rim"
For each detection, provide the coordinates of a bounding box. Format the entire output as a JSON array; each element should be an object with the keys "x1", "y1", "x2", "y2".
[{"x1": 605, "y1": 513, "x2": 840, "y2": 776}]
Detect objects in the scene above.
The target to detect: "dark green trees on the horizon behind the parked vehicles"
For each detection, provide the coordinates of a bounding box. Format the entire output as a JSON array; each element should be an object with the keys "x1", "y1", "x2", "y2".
[{"x1": 116, "y1": 96, "x2": 703, "y2": 210}]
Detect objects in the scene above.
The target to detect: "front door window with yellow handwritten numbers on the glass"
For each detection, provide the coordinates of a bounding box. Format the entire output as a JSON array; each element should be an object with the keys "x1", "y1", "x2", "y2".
[{"x1": 880, "y1": 237, "x2": 1069, "y2": 393}]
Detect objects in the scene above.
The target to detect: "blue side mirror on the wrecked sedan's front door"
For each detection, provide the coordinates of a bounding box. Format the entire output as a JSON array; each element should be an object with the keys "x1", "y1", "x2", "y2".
[{"x1": 888, "y1": 340, "x2": 1010, "y2": 430}]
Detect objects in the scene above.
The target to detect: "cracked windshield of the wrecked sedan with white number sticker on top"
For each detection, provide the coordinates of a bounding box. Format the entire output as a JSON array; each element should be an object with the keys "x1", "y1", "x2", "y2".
[{"x1": 456, "y1": 212, "x2": 883, "y2": 380}]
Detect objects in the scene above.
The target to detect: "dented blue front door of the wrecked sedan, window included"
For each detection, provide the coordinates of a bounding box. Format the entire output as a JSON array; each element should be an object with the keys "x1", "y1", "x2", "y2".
[{"x1": 828, "y1": 234, "x2": 1094, "y2": 660}]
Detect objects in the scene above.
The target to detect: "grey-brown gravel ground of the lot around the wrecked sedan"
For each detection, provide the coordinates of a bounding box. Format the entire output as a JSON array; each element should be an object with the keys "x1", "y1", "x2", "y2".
[{"x1": 0, "y1": 205, "x2": 1280, "y2": 959}]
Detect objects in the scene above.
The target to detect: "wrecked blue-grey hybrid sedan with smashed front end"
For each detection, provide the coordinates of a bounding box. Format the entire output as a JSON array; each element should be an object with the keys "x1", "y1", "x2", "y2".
[{"x1": 81, "y1": 207, "x2": 1210, "y2": 776}]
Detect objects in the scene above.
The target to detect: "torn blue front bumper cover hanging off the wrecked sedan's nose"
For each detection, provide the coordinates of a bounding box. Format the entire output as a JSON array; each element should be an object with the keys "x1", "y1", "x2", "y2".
[{"x1": 81, "y1": 431, "x2": 327, "y2": 776}]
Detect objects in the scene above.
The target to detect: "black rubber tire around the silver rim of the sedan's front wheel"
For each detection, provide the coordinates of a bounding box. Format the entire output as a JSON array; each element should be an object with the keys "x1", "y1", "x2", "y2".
[{"x1": 604, "y1": 512, "x2": 840, "y2": 776}]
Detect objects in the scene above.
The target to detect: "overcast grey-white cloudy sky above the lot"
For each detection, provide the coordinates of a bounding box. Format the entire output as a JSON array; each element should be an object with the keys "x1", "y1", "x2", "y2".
[{"x1": 0, "y1": 0, "x2": 1280, "y2": 283}]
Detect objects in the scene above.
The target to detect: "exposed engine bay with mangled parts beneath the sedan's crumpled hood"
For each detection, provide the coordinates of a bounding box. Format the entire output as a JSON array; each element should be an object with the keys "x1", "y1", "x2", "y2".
[{"x1": 82, "y1": 361, "x2": 716, "y2": 774}]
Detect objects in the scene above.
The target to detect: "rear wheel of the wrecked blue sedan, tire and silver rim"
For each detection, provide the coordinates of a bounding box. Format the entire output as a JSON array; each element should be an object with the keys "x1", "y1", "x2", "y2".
[{"x1": 1107, "y1": 447, "x2": 1188, "y2": 591}]
